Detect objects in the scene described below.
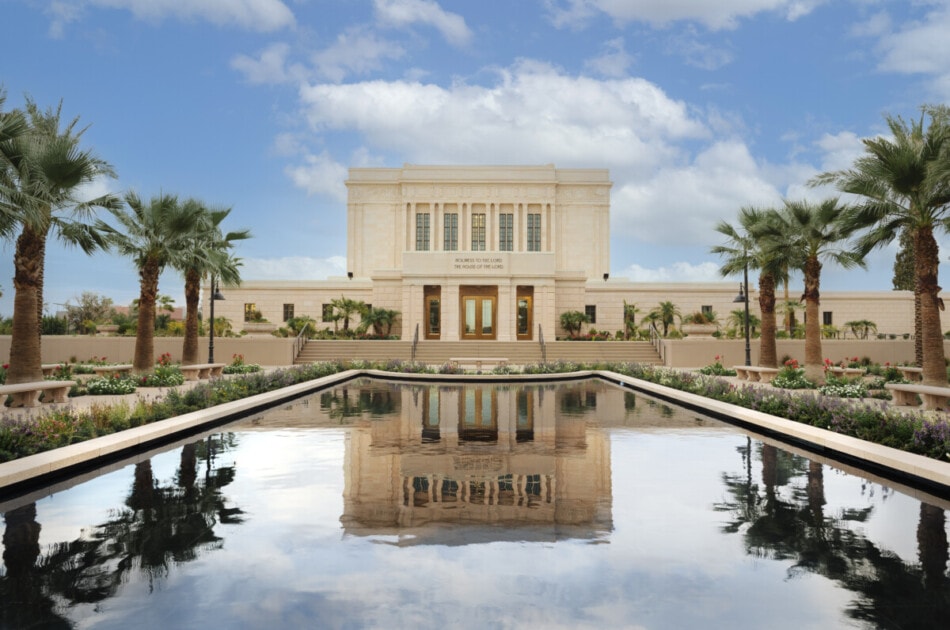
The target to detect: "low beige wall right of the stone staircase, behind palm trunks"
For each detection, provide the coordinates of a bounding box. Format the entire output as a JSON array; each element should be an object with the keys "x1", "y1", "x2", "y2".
[{"x1": 661, "y1": 339, "x2": 928, "y2": 368}]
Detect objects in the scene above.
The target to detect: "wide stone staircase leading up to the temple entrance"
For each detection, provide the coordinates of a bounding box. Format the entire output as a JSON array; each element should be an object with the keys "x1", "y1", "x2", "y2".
[{"x1": 294, "y1": 340, "x2": 662, "y2": 365}]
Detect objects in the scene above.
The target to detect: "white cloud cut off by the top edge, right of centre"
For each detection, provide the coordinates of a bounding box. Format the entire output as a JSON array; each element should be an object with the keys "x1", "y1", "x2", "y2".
[{"x1": 546, "y1": 0, "x2": 826, "y2": 30}]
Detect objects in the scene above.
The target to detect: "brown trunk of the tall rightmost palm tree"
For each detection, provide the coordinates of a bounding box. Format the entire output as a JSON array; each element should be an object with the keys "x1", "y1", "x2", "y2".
[{"x1": 914, "y1": 227, "x2": 947, "y2": 385}]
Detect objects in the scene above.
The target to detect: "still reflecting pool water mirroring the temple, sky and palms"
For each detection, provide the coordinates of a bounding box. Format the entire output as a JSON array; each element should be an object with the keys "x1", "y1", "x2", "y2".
[{"x1": 0, "y1": 379, "x2": 950, "y2": 630}]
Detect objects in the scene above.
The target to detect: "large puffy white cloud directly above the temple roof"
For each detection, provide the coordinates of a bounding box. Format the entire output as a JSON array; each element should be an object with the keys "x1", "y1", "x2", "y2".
[{"x1": 301, "y1": 61, "x2": 708, "y2": 169}]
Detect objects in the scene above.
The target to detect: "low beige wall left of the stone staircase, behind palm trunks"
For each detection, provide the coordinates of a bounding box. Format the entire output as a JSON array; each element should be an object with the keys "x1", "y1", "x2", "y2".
[{"x1": 0, "y1": 335, "x2": 294, "y2": 366}]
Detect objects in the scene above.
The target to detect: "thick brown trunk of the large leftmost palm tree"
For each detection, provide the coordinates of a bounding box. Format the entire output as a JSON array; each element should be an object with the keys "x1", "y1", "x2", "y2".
[{"x1": 7, "y1": 226, "x2": 46, "y2": 385}]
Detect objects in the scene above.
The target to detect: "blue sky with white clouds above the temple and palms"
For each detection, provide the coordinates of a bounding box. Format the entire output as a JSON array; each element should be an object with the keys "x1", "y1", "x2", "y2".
[{"x1": 0, "y1": 0, "x2": 950, "y2": 316}]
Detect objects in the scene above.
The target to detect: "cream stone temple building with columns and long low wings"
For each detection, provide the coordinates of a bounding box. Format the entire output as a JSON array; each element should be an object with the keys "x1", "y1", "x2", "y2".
[{"x1": 210, "y1": 165, "x2": 913, "y2": 341}]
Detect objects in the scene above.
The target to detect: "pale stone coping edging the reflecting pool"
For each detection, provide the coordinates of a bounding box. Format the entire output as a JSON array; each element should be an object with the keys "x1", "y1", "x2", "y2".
[{"x1": 0, "y1": 369, "x2": 950, "y2": 495}]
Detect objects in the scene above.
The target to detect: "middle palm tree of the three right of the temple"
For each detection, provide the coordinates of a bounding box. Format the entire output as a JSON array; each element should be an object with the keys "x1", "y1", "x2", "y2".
[{"x1": 770, "y1": 198, "x2": 864, "y2": 383}]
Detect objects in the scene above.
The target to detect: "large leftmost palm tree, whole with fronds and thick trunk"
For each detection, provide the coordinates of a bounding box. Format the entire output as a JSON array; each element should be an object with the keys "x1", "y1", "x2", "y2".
[{"x1": 0, "y1": 97, "x2": 121, "y2": 384}]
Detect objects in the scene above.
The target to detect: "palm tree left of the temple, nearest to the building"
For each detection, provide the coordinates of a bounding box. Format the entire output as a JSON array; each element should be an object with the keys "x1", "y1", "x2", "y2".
[{"x1": 173, "y1": 199, "x2": 251, "y2": 365}]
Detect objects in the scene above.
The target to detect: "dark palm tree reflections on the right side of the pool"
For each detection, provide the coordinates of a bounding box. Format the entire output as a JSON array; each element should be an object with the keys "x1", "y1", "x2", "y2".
[{"x1": 716, "y1": 446, "x2": 950, "y2": 628}]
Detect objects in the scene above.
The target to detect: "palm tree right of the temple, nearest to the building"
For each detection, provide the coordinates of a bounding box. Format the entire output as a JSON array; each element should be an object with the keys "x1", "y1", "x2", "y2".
[{"x1": 710, "y1": 206, "x2": 788, "y2": 368}]
